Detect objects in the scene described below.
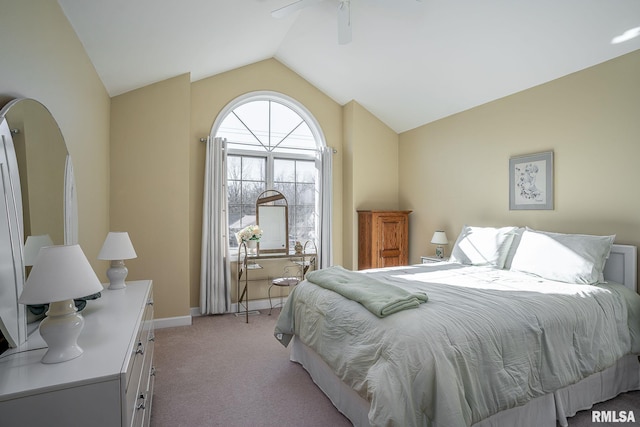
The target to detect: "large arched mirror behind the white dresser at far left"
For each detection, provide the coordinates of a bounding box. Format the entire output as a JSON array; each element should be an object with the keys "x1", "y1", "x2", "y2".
[{"x1": 0, "y1": 98, "x2": 77, "y2": 352}]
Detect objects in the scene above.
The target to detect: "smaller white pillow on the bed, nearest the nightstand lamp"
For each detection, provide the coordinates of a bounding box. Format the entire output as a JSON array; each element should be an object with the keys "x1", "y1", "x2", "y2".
[{"x1": 450, "y1": 225, "x2": 517, "y2": 268}]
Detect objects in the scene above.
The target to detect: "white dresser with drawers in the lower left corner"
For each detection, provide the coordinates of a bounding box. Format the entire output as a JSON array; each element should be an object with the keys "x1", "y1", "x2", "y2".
[{"x1": 0, "y1": 280, "x2": 154, "y2": 427}]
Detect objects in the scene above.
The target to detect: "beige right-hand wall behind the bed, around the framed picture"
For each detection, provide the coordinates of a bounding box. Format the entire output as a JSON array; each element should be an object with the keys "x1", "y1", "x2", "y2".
[{"x1": 400, "y1": 51, "x2": 640, "y2": 270}]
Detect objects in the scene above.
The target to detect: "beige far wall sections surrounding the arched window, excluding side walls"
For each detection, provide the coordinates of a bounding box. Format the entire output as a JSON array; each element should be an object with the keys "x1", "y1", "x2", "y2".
[{"x1": 111, "y1": 59, "x2": 390, "y2": 318}]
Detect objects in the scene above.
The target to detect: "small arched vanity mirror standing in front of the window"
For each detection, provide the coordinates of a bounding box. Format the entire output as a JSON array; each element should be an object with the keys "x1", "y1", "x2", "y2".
[{"x1": 256, "y1": 190, "x2": 289, "y2": 254}]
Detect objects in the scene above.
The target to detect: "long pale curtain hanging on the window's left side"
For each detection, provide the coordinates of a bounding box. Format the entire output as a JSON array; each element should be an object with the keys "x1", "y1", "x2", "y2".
[{"x1": 200, "y1": 137, "x2": 231, "y2": 315}]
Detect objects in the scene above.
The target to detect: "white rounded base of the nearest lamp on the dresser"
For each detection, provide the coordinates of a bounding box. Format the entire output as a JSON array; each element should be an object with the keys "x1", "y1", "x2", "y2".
[{"x1": 40, "y1": 299, "x2": 84, "y2": 363}]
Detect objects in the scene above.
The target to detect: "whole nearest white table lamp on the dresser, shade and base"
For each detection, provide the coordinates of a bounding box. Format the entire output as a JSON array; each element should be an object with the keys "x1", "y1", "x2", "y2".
[{"x1": 18, "y1": 245, "x2": 102, "y2": 363}]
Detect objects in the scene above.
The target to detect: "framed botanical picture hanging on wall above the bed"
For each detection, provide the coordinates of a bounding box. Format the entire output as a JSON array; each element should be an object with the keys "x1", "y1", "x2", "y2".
[{"x1": 509, "y1": 151, "x2": 553, "y2": 210}]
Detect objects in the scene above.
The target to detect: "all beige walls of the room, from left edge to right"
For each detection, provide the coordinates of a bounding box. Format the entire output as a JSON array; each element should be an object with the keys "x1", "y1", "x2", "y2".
[{"x1": 5, "y1": 0, "x2": 640, "y2": 317}]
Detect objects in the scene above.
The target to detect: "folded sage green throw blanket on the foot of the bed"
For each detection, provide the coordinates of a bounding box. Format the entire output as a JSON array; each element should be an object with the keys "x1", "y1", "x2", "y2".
[{"x1": 307, "y1": 266, "x2": 428, "y2": 317}]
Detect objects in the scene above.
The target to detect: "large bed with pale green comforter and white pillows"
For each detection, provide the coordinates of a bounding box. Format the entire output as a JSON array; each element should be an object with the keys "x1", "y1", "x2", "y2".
[{"x1": 275, "y1": 226, "x2": 640, "y2": 427}]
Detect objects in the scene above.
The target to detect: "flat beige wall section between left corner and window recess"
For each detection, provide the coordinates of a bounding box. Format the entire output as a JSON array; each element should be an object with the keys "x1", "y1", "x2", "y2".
[{"x1": 110, "y1": 74, "x2": 191, "y2": 318}]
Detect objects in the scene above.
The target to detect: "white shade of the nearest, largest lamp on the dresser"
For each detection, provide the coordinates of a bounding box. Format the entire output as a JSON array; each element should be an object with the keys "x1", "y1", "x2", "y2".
[{"x1": 18, "y1": 245, "x2": 104, "y2": 304}]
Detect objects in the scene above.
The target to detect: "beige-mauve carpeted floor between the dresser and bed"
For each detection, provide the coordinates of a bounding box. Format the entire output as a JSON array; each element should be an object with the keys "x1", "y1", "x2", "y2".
[{"x1": 151, "y1": 310, "x2": 640, "y2": 427}]
